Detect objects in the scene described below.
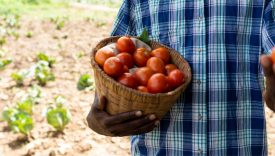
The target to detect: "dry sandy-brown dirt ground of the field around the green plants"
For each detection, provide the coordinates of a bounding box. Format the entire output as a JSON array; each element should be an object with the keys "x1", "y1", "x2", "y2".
[{"x1": 0, "y1": 7, "x2": 275, "y2": 156}]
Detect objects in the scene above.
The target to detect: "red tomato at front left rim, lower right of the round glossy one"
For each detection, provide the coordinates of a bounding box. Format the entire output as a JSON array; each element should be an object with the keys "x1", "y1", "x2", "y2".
[{"x1": 117, "y1": 73, "x2": 138, "y2": 89}]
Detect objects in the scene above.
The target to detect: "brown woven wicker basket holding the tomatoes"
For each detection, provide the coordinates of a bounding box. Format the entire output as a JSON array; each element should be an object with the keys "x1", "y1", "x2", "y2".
[{"x1": 91, "y1": 36, "x2": 191, "y2": 119}]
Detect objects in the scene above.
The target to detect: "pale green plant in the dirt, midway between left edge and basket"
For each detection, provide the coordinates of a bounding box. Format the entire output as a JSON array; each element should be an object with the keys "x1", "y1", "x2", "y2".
[{"x1": 34, "y1": 61, "x2": 55, "y2": 86}]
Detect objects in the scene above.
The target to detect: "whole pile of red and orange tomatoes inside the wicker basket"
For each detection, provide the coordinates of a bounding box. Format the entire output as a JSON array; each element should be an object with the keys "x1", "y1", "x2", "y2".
[{"x1": 95, "y1": 36, "x2": 188, "y2": 93}]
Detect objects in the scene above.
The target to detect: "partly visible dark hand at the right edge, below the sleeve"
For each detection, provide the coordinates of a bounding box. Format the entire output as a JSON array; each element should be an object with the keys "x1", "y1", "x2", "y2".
[{"x1": 261, "y1": 55, "x2": 275, "y2": 112}]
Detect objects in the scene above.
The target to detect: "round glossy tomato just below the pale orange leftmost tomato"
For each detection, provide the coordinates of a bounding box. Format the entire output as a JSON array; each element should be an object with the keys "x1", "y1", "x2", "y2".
[{"x1": 103, "y1": 57, "x2": 124, "y2": 77}]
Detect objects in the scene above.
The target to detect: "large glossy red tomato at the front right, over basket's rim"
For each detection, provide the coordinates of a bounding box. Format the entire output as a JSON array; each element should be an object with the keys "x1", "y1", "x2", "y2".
[{"x1": 147, "y1": 73, "x2": 167, "y2": 93}]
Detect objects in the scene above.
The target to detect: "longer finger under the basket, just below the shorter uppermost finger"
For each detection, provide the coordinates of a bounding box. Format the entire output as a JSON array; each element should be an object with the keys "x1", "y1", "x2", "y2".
[{"x1": 109, "y1": 115, "x2": 156, "y2": 135}]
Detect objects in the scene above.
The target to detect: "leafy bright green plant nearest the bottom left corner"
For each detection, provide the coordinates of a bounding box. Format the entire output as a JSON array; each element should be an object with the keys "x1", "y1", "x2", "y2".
[{"x1": 2, "y1": 108, "x2": 34, "y2": 135}]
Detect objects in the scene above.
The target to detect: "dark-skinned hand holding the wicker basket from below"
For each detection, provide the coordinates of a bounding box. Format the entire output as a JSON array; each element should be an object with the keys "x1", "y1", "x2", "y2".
[{"x1": 87, "y1": 94, "x2": 159, "y2": 136}]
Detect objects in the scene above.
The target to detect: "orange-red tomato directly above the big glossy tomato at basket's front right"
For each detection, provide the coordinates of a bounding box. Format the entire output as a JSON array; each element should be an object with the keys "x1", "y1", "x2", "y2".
[{"x1": 147, "y1": 57, "x2": 165, "y2": 74}]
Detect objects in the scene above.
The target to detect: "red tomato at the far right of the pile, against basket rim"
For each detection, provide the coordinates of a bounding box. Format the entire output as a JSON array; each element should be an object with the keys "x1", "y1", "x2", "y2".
[{"x1": 168, "y1": 69, "x2": 185, "y2": 89}]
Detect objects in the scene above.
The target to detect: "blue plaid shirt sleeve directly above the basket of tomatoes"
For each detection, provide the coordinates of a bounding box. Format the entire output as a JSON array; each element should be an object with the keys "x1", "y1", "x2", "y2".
[{"x1": 111, "y1": 0, "x2": 136, "y2": 36}]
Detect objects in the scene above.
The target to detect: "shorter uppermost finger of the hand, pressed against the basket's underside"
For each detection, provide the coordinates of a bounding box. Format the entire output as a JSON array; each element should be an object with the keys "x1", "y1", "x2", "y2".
[{"x1": 106, "y1": 111, "x2": 142, "y2": 126}]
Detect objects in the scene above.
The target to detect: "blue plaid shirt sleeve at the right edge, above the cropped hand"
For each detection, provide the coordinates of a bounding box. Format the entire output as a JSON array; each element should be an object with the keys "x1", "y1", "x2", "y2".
[{"x1": 262, "y1": 0, "x2": 275, "y2": 54}]
